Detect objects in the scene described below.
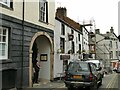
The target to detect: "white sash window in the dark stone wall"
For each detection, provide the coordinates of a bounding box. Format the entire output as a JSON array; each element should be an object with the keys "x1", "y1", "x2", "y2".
[{"x1": 0, "y1": 27, "x2": 8, "y2": 59}]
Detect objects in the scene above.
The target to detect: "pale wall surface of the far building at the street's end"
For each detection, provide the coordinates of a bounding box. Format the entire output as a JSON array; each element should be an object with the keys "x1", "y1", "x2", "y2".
[{"x1": 96, "y1": 34, "x2": 118, "y2": 67}]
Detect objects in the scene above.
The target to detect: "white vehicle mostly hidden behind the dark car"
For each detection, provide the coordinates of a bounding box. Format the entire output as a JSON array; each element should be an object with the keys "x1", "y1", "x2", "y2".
[{"x1": 86, "y1": 59, "x2": 106, "y2": 78}]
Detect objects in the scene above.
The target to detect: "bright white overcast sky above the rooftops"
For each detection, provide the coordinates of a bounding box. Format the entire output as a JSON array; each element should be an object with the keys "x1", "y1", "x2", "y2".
[{"x1": 55, "y1": 0, "x2": 120, "y2": 36}]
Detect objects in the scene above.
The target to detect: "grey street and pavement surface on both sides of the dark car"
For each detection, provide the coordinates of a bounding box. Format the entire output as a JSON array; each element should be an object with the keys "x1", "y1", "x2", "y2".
[{"x1": 31, "y1": 72, "x2": 120, "y2": 90}]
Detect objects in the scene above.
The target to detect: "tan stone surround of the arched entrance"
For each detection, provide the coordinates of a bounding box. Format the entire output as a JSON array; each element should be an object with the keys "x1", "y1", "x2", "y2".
[{"x1": 29, "y1": 32, "x2": 54, "y2": 87}]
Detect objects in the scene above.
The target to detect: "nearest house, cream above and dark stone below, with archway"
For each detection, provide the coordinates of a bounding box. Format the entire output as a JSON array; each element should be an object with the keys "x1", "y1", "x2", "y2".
[{"x1": 0, "y1": 0, "x2": 55, "y2": 88}]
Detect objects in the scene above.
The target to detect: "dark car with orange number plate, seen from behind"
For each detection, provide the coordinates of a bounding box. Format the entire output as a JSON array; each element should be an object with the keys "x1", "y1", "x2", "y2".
[{"x1": 64, "y1": 61, "x2": 102, "y2": 90}]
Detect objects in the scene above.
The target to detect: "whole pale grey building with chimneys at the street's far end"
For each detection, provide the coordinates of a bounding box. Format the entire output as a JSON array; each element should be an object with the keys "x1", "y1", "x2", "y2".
[{"x1": 96, "y1": 27, "x2": 119, "y2": 70}]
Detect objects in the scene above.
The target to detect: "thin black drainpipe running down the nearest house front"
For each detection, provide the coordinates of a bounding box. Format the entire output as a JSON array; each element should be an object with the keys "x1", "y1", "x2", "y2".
[{"x1": 20, "y1": 0, "x2": 25, "y2": 89}]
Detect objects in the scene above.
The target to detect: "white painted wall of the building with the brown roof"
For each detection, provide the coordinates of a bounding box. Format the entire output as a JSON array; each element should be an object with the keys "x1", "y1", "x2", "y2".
[{"x1": 54, "y1": 20, "x2": 82, "y2": 78}]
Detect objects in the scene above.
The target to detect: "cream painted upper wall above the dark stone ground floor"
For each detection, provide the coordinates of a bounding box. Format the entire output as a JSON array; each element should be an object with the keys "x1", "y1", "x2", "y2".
[{"x1": 0, "y1": 0, "x2": 55, "y2": 30}]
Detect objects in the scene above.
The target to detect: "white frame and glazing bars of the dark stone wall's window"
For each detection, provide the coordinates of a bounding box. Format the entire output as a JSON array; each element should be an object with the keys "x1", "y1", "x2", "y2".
[{"x1": 0, "y1": 27, "x2": 9, "y2": 60}]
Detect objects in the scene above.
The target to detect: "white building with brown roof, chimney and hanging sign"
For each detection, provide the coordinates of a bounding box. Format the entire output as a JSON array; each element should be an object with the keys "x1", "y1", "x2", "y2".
[{"x1": 54, "y1": 8, "x2": 82, "y2": 78}]
